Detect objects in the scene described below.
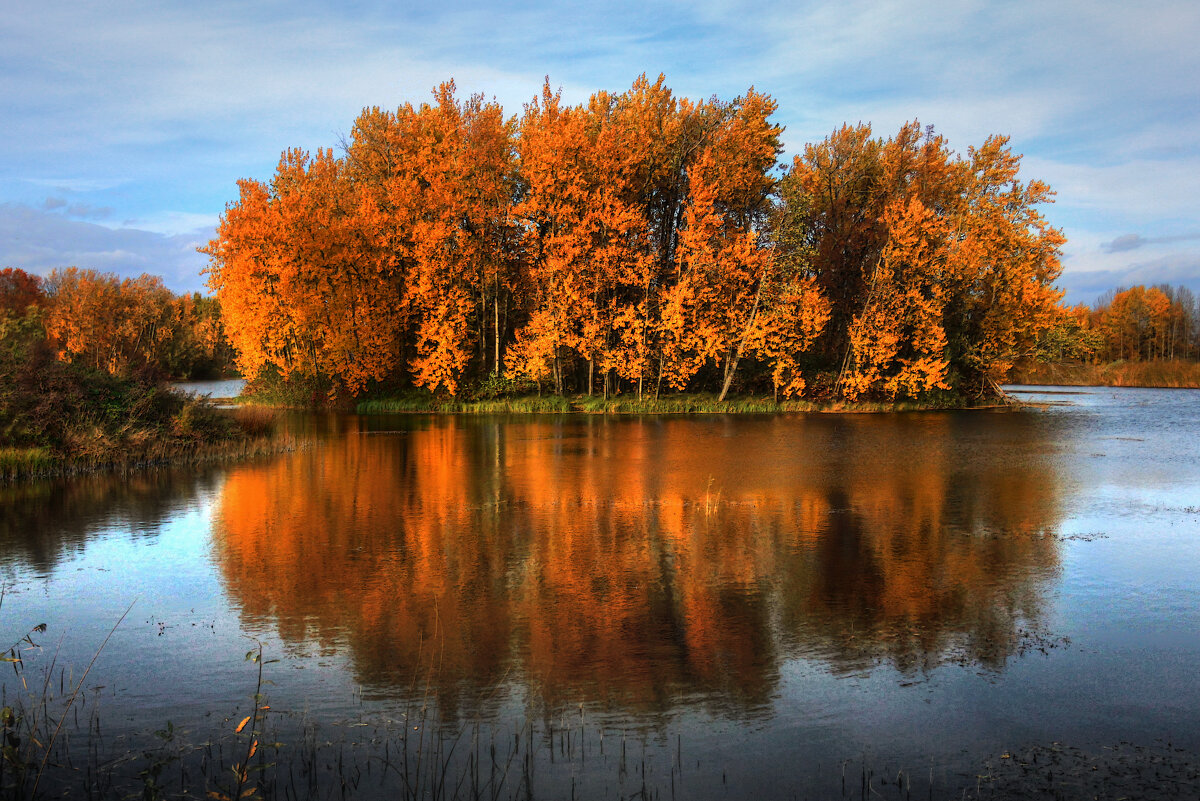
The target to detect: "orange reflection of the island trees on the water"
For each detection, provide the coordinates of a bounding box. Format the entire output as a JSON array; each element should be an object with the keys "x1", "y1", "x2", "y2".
[{"x1": 215, "y1": 414, "x2": 1061, "y2": 715}]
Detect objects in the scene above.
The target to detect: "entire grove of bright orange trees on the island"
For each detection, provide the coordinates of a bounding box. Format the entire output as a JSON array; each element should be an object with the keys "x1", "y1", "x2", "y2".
[{"x1": 205, "y1": 77, "x2": 1063, "y2": 401}]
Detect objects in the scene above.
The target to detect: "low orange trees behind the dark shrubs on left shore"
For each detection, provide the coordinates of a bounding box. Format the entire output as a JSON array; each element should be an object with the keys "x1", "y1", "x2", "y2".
[{"x1": 0, "y1": 267, "x2": 233, "y2": 379}]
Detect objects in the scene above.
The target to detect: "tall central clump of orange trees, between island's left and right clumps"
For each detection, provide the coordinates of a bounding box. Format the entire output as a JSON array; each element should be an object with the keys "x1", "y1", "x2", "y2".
[{"x1": 511, "y1": 76, "x2": 796, "y2": 395}]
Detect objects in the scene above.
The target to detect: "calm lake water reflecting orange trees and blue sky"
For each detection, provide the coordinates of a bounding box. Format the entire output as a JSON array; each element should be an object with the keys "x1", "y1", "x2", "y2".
[{"x1": 0, "y1": 390, "x2": 1200, "y2": 797}]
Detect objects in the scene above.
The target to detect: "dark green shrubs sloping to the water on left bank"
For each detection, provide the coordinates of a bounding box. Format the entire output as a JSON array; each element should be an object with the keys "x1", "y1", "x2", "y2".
[{"x1": 0, "y1": 307, "x2": 278, "y2": 481}]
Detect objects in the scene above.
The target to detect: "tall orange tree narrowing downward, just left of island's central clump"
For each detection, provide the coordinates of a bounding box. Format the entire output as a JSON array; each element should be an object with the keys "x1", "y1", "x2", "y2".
[{"x1": 347, "y1": 82, "x2": 522, "y2": 395}]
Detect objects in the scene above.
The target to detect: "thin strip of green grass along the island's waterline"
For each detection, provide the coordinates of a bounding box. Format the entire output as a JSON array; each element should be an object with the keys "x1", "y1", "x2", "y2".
[{"x1": 355, "y1": 392, "x2": 1008, "y2": 415}]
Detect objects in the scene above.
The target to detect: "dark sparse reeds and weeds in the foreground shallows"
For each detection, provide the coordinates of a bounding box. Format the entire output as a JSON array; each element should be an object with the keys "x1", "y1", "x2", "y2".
[{"x1": 7, "y1": 618, "x2": 1200, "y2": 801}]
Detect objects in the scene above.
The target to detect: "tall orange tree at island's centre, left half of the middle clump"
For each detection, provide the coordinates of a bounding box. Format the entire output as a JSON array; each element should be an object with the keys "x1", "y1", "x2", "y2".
[{"x1": 509, "y1": 82, "x2": 654, "y2": 393}]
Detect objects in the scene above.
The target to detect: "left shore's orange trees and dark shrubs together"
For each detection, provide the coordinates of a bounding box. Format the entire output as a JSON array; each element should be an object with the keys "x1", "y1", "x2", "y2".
[{"x1": 0, "y1": 267, "x2": 276, "y2": 482}]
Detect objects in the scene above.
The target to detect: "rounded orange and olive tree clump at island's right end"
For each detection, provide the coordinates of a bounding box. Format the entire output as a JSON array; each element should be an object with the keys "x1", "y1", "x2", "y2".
[{"x1": 776, "y1": 122, "x2": 1064, "y2": 398}]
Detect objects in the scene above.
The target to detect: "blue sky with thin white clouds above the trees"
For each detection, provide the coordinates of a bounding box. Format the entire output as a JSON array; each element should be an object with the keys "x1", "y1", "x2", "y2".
[{"x1": 0, "y1": 0, "x2": 1200, "y2": 303}]
